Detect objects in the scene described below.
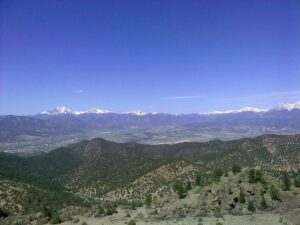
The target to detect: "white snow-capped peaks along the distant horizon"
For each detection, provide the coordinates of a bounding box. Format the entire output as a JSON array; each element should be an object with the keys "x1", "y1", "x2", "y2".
[{"x1": 41, "y1": 101, "x2": 300, "y2": 116}]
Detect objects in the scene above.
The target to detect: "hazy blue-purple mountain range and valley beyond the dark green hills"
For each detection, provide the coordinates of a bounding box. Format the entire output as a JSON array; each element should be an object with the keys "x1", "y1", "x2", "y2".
[{"x1": 0, "y1": 102, "x2": 300, "y2": 152}]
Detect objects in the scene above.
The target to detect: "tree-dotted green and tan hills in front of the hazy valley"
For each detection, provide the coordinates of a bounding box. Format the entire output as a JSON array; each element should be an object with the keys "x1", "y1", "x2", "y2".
[{"x1": 0, "y1": 135, "x2": 300, "y2": 224}]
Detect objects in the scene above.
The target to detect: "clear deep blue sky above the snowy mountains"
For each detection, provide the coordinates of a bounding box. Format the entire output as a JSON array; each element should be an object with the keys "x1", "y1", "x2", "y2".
[{"x1": 0, "y1": 0, "x2": 300, "y2": 114}]
